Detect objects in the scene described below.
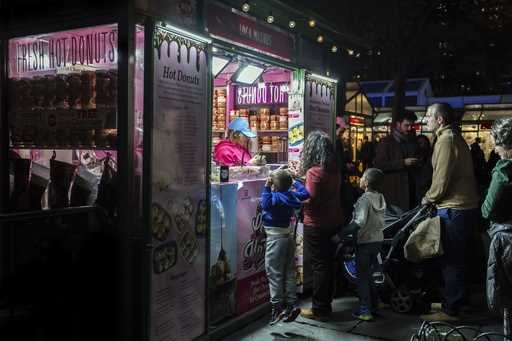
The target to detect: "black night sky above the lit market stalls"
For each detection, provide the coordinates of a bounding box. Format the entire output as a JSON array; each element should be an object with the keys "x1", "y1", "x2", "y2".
[{"x1": 293, "y1": 0, "x2": 512, "y2": 96}]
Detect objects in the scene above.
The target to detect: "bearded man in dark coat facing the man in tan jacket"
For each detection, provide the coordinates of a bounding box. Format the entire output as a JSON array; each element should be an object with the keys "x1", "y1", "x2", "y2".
[{"x1": 374, "y1": 111, "x2": 419, "y2": 211}]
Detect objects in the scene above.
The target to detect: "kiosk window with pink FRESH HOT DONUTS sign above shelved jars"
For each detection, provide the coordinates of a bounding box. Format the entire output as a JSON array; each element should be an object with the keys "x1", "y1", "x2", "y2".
[{"x1": 8, "y1": 24, "x2": 118, "y2": 149}]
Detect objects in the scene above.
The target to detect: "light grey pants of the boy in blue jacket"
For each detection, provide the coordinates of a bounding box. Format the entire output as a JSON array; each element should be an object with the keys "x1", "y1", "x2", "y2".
[{"x1": 265, "y1": 228, "x2": 297, "y2": 308}]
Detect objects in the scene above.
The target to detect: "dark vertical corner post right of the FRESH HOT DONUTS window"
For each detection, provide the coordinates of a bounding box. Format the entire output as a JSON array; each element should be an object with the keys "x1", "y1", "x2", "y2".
[{"x1": 116, "y1": 0, "x2": 140, "y2": 341}]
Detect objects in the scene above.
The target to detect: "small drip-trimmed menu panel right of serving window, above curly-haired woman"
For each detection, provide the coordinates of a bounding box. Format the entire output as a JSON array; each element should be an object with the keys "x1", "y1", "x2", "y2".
[{"x1": 305, "y1": 75, "x2": 336, "y2": 137}]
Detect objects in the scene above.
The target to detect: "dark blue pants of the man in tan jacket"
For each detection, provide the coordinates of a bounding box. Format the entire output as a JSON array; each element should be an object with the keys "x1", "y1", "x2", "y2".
[{"x1": 437, "y1": 209, "x2": 479, "y2": 315}]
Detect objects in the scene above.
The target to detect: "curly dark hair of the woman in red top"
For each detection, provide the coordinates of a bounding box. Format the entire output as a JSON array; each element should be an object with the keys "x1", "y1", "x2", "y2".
[{"x1": 301, "y1": 130, "x2": 337, "y2": 174}]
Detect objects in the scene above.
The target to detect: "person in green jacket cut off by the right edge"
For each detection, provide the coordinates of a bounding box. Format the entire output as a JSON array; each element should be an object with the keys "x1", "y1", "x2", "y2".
[{"x1": 482, "y1": 118, "x2": 512, "y2": 312}]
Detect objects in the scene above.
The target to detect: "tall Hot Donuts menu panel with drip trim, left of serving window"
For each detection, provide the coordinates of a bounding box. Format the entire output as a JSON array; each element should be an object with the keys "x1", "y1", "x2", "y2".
[{"x1": 151, "y1": 29, "x2": 209, "y2": 341}]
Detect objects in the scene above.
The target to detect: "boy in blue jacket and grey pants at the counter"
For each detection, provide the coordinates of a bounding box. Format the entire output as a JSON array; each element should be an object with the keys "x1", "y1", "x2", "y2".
[{"x1": 261, "y1": 169, "x2": 309, "y2": 326}]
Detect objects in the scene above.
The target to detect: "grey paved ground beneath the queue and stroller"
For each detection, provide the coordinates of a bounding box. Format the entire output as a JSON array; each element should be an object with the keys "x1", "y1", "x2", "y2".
[{"x1": 224, "y1": 297, "x2": 501, "y2": 341}]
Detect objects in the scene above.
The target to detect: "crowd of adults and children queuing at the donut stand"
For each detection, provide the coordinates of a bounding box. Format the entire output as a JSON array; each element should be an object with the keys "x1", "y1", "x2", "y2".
[{"x1": 262, "y1": 103, "x2": 512, "y2": 324}]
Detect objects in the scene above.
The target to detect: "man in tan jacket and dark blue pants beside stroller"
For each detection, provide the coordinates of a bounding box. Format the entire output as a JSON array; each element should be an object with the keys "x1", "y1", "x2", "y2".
[{"x1": 422, "y1": 103, "x2": 479, "y2": 321}]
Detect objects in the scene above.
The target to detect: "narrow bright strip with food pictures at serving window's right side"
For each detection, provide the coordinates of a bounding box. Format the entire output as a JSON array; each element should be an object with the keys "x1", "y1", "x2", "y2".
[{"x1": 288, "y1": 70, "x2": 306, "y2": 162}]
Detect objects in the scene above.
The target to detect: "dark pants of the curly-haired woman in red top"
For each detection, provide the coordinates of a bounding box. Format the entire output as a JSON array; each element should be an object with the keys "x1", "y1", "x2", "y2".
[{"x1": 304, "y1": 226, "x2": 336, "y2": 315}]
